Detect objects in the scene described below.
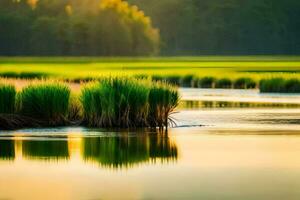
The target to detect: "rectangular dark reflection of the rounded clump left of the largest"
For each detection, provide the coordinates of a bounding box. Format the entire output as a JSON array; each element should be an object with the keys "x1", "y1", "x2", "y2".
[{"x1": 22, "y1": 140, "x2": 70, "y2": 160}]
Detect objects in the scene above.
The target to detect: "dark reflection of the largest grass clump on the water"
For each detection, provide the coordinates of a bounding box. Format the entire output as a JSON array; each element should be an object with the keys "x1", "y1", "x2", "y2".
[{"x1": 82, "y1": 135, "x2": 178, "y2": 168}]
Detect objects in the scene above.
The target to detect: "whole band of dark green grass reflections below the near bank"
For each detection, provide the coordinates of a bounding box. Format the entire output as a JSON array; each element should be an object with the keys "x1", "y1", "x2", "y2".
[{"x1": 0, "y1": 133, "x2": 178, "y2": 168}]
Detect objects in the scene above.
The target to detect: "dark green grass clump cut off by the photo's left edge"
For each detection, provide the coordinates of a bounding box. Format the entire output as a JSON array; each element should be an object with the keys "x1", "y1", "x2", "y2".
[{"x1": 0, "y1": 84, "x2": 16, "y2": 114}]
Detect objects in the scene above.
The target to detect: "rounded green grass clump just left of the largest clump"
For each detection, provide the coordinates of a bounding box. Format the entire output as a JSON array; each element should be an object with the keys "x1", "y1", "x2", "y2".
[{"x1": 18, "y1": 83, "x2": 70, "y2": 125}]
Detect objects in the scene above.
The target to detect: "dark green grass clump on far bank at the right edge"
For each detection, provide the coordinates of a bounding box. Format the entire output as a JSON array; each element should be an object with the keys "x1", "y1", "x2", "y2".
[{"x1": 259, "y1": 78, "x2": 300, "y2": 93}]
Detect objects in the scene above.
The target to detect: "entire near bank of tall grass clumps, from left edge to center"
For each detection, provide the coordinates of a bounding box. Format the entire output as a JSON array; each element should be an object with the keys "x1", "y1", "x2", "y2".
[{"x1": 0, "y1": 77, "x2": 179, "y2": 129}]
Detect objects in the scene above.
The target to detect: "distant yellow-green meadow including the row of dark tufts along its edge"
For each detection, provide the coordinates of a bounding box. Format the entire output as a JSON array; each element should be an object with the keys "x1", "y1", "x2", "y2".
[{"x1": 0, "y1": 56, "x2": 300, "y2": 92}]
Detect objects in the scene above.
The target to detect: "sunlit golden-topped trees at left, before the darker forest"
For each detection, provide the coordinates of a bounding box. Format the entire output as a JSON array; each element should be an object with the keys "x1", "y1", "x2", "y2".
[{"x1": 0, "y1": 0, "x2": 159, "y2": 56}]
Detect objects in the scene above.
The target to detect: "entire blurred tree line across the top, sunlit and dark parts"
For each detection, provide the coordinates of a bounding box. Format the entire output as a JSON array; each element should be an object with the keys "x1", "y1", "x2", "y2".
[{"x1": 0, "y1": 0, "x2": 300, "y2": 56}]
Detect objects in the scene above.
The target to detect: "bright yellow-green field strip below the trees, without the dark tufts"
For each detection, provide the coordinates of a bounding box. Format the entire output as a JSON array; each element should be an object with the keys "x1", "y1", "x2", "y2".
[{"x1": 0, "y1": 56, "x2": 300, "y2": 80}]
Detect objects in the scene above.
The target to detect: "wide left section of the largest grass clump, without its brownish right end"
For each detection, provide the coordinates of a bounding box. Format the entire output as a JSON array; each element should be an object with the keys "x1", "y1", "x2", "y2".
[{"x1": 81, "y1": 77, "x2": 149, "y2": 127}]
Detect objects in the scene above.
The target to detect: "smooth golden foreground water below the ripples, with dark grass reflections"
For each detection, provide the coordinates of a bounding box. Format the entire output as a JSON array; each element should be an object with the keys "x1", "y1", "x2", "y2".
[{"x1": 0, "y1": 128, "x2": 300, "y2": 200}]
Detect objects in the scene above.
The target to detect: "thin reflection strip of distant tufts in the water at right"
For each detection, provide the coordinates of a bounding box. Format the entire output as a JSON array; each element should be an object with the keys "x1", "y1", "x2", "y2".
[{"x1": 180, "y1": 101, "x2": 300, "y2": 109}]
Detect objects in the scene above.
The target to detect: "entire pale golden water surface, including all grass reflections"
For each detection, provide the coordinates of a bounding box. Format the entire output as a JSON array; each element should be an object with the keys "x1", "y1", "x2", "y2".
[{"x1": 0, "y1": 89, "x2": 300, "y2": 200}]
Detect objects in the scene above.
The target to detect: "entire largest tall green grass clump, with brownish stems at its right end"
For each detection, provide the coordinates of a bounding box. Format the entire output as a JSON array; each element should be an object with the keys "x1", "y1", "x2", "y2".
[{"x1": 81, "y1": 77, "x2": 179, "y2": 127}]
